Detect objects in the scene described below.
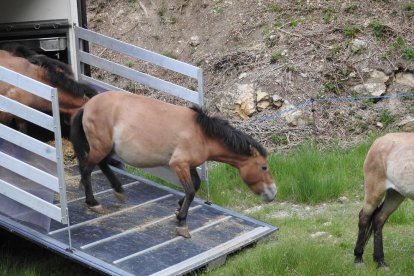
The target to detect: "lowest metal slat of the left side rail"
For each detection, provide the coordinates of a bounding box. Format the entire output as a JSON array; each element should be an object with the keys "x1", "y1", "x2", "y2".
[{"x1": 0, "y1": 179, "x2": 61, "y2": 221}]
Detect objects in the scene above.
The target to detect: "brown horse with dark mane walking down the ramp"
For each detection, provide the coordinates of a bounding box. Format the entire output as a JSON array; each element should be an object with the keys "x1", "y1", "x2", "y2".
[{"x1": 71, "y1": 91, "x2": 276, "y2": 238}]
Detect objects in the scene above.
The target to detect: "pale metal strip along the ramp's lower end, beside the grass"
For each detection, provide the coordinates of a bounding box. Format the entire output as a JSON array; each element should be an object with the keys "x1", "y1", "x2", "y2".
[{"x1": 152, "y1": 227, "x2": 267, "y2": 276}]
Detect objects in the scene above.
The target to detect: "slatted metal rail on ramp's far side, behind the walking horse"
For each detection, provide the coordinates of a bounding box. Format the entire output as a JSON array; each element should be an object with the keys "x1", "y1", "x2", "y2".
[{"x1": 73, "y1": 26, "x2": 208, "y2": 185}]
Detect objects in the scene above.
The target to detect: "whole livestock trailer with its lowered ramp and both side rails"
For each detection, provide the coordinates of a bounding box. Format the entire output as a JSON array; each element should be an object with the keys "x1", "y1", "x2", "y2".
[{"x1": 0, "y1": 0, "x2": 277, "y2": 275}]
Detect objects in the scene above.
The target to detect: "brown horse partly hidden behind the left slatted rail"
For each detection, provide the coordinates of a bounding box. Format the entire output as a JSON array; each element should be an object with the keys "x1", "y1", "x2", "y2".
[{"x1": 0, "y1": 46, "x2": 96, "y2": 132}]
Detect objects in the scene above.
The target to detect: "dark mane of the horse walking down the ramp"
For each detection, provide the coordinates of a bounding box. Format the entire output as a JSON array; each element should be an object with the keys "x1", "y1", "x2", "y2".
[{"x1": 191, "y1": 106, "x2": 267, "y2": 157}]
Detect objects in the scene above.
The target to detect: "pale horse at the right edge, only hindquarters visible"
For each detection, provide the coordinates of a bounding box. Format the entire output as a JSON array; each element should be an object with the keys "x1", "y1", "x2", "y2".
[{"x1": 354, "y1": 133, "x2": 414, "y2": 267}]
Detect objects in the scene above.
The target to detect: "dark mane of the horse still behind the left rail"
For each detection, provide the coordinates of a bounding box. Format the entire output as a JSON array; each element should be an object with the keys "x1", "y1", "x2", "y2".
[{"x1": 2, "y1": 43, "x2": 97, "y2": 98}]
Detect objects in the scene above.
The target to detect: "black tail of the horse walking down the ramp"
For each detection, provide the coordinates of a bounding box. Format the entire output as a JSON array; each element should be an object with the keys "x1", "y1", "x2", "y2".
[{"x1": 70, "y1": 108, "x2": 89, "y2": 168}]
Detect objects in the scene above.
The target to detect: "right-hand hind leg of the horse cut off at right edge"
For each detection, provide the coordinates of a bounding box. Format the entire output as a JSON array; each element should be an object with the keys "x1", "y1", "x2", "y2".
[{"x1": 373, "y1": 189, "x2": 404, "y2": 267}]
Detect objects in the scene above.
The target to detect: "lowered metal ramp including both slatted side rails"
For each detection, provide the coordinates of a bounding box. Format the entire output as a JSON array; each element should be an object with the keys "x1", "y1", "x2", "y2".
[{"x1": 0, "y1": 27, "x2": 277, "y2": 275}]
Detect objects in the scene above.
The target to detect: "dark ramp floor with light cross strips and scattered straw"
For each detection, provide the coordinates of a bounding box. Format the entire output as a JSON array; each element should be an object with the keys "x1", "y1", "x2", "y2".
[{"x1": 0, "y1": 165, "x2": 277, "y2": 275}]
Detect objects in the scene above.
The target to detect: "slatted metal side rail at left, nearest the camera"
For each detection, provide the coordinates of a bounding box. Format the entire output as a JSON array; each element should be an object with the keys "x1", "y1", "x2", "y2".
[{"x1": 0, "y1": 66, "x2": 69, "y2": 224}]
